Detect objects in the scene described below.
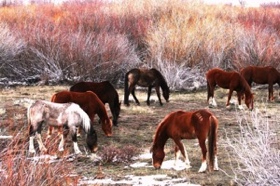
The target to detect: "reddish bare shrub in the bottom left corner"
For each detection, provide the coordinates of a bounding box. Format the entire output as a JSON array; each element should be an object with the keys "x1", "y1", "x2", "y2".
[{"x1": 0, "y1": 133, "x2": 79, "y2": 186}]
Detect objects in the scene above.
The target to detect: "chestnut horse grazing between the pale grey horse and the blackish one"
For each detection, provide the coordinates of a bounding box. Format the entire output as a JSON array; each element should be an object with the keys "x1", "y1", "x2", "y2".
[{"x1": 49, "y1": 90, "x2": 112, "y2": 136}]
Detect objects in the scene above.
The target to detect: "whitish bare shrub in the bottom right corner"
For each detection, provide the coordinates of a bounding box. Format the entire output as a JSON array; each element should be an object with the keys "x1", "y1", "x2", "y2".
[{"x1": 225, "y1": 111, "x2": 280, "y2": 185}]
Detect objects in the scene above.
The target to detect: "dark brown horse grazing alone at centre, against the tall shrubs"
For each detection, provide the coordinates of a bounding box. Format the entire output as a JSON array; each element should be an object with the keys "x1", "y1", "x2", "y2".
[{"x1": 124, "y1": 68, "x2": 169, "y2": 106}]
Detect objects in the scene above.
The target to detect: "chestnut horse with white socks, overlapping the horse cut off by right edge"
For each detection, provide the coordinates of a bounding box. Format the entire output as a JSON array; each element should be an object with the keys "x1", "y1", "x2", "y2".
[{"x1": 206, "y1": 68, "x2": 254, "y2": 110}]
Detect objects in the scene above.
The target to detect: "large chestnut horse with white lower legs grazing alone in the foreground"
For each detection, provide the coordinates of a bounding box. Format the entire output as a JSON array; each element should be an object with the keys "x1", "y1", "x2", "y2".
[{"x1": 151, "y1": 109, "x2": 219, "y2": 172}]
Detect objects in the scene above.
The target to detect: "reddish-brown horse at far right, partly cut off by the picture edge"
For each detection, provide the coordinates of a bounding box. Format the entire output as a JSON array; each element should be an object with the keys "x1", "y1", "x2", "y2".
[{"x1": 240, "y1": 66, "x2": 280, "y2": 101}]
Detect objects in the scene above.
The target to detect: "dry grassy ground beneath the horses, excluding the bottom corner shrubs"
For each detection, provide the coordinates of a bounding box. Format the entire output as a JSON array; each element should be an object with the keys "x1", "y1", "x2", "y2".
[{"x1": 0, "y1": 86, "x2": 280, "y2": 185}]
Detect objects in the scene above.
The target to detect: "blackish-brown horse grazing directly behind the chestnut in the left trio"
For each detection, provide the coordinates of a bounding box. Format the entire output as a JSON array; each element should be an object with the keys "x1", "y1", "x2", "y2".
[{"x1": 70, "y1": 81, "x2": 121, "y2": 126}]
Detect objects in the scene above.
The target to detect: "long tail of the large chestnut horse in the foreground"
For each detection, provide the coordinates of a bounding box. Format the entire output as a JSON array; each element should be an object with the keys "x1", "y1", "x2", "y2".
[{"x1": 208, "y1": 115, "x2": 218, "y2": 169}]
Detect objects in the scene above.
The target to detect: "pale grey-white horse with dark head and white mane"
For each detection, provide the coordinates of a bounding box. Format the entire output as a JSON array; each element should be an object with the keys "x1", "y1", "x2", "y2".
[{"x1": 27, "y1": 100, "x2": 97, "y2": 154}]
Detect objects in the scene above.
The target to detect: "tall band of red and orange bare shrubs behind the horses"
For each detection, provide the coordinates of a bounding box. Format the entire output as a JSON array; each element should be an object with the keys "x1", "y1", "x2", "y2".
[{"x1": 0, "y1": 0, "x2": 280, "y2": 90}]
